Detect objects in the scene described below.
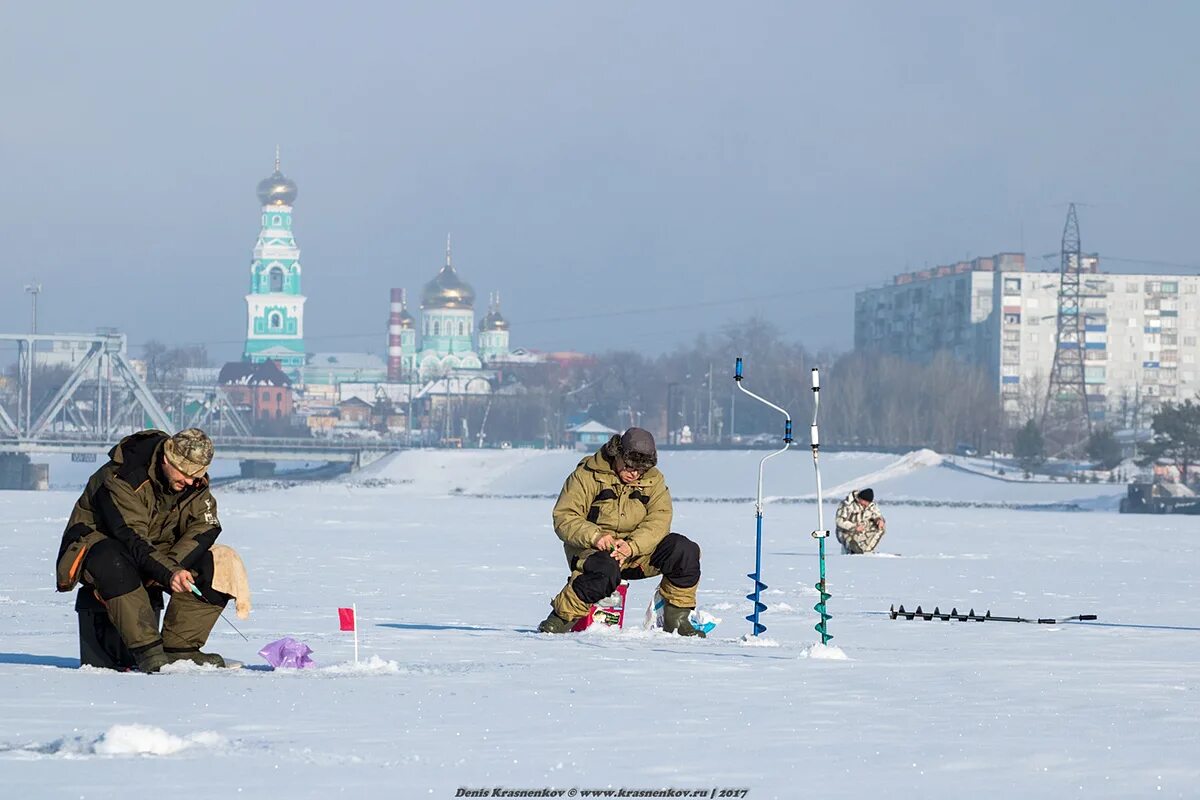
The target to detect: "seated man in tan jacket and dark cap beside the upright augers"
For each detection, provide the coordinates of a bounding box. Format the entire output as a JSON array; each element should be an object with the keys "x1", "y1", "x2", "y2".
[{"x1": 538, "y1": 428, "x2": 704, "y2": 637}]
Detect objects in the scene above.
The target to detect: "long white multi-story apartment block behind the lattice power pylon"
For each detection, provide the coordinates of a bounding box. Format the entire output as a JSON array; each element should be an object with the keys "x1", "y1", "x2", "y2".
[{"x1": 854, "y1": 253, "x2": 1200, "y2": 426}]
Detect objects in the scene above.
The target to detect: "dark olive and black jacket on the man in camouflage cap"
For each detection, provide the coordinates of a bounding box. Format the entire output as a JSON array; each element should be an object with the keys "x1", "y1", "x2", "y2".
[{"x1": 55, "y1": 431, "x2": 221, "y2": 591}]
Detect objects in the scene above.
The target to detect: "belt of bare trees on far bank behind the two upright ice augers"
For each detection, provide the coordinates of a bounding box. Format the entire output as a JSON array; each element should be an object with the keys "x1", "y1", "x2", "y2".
[{"x1": 490, "y1": 319, "x2": 1008, "y2": 452}]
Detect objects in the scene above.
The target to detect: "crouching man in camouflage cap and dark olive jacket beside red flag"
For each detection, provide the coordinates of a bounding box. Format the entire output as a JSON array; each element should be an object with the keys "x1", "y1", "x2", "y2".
[{"x1": 56, "y1": 428, "x2": 229, "y2": 673}]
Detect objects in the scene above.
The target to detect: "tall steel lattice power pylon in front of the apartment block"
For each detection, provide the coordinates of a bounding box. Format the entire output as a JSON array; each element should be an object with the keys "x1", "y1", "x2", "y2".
[{"x1": 1042, "y1": 203, "x2": 1092, "y2": 452}]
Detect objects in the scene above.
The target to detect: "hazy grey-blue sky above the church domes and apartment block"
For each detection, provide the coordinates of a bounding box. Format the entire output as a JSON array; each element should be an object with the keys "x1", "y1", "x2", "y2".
[{"x1": 0, "y1": 2, "x2": 1200, "y2": 360}]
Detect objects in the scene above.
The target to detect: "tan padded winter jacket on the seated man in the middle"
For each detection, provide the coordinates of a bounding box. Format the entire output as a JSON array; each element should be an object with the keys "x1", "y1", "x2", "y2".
[{"x1": 553, "y1": 437, "x2": 672, "y2": 565}]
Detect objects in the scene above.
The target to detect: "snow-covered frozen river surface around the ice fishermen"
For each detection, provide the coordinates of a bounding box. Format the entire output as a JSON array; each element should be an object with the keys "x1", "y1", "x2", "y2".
[{"x1": 0, "y1": 450, "x2": 1200, "y2": 800}]
